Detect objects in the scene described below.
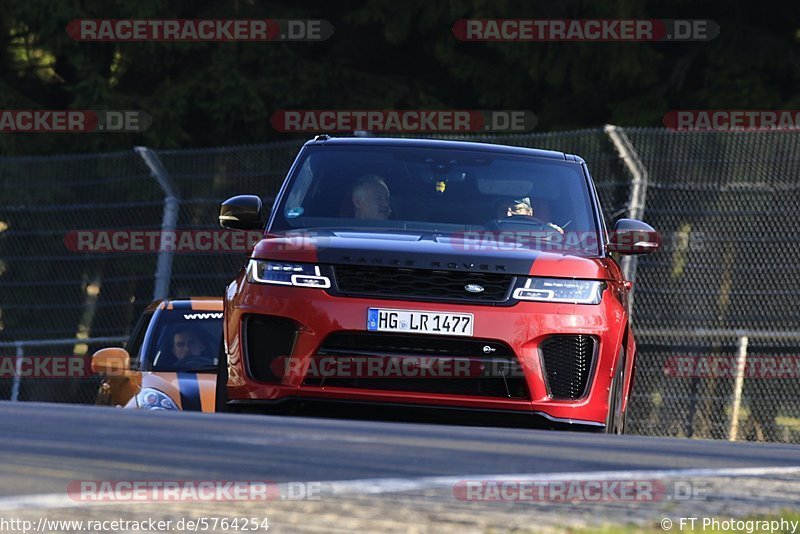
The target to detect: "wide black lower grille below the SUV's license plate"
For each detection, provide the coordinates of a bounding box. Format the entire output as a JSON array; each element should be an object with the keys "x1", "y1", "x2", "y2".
[{"x1": 303, "y1": 332, "x2": 530, "y2": 399}]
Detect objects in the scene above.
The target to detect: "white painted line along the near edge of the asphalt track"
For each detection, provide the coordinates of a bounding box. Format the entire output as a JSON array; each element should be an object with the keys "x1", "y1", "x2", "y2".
[{"x1": 0, "y1": 466, "x2": 800, "y2": 512}]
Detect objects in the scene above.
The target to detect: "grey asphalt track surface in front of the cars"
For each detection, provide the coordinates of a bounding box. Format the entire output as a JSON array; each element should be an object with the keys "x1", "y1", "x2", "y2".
[{"x1": 0, "y1": 402, "x2": 800, "y2": 498}]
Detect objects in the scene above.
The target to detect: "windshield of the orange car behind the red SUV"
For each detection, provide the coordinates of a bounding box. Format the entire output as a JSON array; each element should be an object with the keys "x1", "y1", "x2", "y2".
[{"x1": 147, "y1": 309, "x2": 222, "y2": 372}]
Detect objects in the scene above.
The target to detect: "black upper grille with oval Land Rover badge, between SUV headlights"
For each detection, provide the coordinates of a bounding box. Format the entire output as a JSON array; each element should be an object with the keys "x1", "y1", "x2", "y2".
[{"x1": 334, "y1": 265, "x2": 514, "y2": 304}]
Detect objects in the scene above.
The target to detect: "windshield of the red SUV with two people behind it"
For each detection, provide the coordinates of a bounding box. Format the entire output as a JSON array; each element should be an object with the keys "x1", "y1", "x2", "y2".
[{"x1": 271, "y1": 146, "x2": 598, "y2": 254}]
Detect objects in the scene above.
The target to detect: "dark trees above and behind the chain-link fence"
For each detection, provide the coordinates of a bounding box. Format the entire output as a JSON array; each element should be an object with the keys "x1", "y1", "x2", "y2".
[{"x1": 0, "y1": 0, "x2": 800, "y2": 155}]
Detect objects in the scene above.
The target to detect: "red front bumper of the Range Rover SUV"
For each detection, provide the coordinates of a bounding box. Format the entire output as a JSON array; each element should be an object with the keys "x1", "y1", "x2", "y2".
[{"x1": 225, "y1": 275, "x2": 627, "y2": 426}]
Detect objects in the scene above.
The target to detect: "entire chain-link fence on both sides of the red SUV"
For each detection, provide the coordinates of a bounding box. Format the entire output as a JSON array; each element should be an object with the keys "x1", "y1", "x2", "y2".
[{"x1": 0, "y1": 128, "x2": 800, "y2": 442}]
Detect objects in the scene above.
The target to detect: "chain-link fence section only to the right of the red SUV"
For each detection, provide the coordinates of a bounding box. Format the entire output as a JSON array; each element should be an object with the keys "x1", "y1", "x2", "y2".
[{"x1": 626, "y1": 129, "x2": 800, "y2": 443}]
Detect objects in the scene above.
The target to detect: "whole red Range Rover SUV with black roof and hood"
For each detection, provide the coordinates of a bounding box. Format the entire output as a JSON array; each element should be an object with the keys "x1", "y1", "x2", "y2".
[{"x1": 219, "y1": 135, "x2": 659, "y2": 433}]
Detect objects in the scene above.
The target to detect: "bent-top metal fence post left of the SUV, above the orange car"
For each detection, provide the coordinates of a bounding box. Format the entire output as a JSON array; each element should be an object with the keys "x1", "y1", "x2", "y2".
[{"x1": 133, "y1": 146, "x2": 180, "y2": 300}]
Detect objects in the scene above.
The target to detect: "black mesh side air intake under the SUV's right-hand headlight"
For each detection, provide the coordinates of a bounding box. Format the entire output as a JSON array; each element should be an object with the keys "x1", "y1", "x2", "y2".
[{"x1": 539, "y1": 335, "x2": 597, "y2": 400}]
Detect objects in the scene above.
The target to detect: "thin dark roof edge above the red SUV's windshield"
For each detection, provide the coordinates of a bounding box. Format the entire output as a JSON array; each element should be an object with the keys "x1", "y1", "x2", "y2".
[{"x1": 304, "y1": 135, "x2": 574, "y2": 161}]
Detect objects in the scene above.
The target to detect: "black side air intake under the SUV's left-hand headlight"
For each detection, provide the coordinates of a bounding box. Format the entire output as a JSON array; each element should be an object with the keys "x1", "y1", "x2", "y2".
[{"x1": 244, "y1": 315, "x2": 297, "y2": 383}]
